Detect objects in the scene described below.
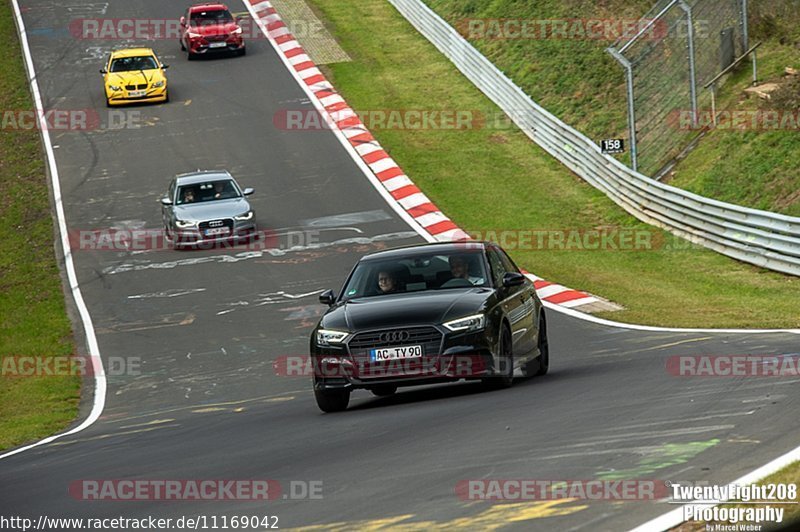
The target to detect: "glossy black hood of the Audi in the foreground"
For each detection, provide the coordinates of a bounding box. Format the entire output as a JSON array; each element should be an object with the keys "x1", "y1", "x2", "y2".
[{"x1": 321, "y1": 287, "x2": 494, "y2": 332}]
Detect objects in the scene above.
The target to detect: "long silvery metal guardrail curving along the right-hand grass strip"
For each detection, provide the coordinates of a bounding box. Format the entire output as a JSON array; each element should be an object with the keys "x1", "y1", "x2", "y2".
[{"x1": 389, "y1": 0, "x2": 800, "y2": 275}]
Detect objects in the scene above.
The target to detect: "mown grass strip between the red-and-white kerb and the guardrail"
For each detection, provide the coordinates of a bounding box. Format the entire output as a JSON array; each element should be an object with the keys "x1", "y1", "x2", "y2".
[{"x1": 304, "y1": 0, "x2": 800, "y2": 328}]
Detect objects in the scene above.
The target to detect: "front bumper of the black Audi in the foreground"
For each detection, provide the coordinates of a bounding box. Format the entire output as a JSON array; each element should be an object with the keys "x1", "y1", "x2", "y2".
[{"x1": 311, "y1": 326, "x2": 495, "y2": 390}]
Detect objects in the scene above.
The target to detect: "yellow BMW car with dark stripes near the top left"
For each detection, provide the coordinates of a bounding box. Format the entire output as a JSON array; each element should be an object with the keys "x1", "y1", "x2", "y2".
[{"x1": 100, "y1": 48, "x2": 169, "y2": 107}]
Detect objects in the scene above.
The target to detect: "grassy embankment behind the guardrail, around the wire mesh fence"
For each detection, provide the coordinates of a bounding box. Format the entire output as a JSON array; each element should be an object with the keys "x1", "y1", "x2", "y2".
[{"x1": 427, "y1": 0, "x2": 800, "y2": 216}]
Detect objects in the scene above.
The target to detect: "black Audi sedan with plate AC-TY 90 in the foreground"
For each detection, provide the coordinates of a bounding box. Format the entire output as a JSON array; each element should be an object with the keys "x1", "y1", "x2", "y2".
[{"x1": 311, "y1": 241, "x2": 550, "y2": 412}]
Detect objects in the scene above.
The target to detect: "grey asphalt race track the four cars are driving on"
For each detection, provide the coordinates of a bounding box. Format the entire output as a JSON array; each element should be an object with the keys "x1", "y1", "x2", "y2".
[{"x1": 0, "y1": 0, "x2": 800, "y2": 530}]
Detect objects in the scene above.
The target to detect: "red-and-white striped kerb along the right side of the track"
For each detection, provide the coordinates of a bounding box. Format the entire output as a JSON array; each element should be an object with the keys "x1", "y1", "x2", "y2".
[{"x1": 244, "y1": 0, "x2": 621, "y2": 312}]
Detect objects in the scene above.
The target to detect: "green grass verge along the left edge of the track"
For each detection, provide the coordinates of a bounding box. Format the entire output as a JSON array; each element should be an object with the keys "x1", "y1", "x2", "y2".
[{"x1": 0, "y1": 2, "x2": 80, "y2": 449}]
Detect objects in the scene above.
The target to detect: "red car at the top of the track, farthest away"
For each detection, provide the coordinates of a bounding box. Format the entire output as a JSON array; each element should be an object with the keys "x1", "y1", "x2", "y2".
[{"x1": 180, "y1": 4, "x2": 247, "y2": 60}]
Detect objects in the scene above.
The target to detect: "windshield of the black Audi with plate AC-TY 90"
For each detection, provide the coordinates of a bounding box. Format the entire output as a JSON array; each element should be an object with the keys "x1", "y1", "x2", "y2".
[{"x1": 342, "y1": 251, "x2": 489, "y2": 300}]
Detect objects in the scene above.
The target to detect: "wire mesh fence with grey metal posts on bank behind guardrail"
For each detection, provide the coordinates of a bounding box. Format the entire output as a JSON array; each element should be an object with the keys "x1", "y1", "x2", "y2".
[{"x1": 608, "y1": 0, "x2": 748, "y2": 175}]
